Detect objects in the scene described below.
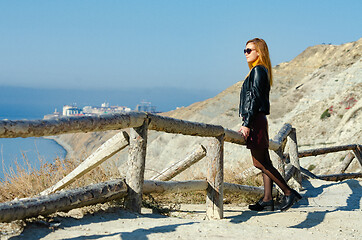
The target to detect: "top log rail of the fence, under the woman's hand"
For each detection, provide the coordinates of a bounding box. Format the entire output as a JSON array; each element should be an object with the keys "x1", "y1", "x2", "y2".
[{"x1": 0, "y1": 112, "x2": 287, "y2": 150}]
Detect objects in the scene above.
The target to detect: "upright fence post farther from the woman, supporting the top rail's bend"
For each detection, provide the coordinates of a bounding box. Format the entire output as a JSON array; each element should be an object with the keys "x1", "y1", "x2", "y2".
[{"x1": 125, "y1": 119, "x2": 148, "y2": 213}]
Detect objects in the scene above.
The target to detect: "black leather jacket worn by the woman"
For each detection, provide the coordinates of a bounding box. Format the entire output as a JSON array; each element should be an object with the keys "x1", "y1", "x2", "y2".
[{"x1": 239, "y1": 65, "x2": 270, "y2": 128}]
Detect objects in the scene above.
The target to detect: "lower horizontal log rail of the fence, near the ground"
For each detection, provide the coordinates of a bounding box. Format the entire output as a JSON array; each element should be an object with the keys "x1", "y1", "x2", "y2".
[{"x1": 0, "y1": 179, "x2": 276, "y2": 222}]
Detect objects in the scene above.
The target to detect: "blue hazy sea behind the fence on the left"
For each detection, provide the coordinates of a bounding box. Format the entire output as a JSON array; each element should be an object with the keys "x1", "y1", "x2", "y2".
[{"x1": 0, "y1": 86, "x2": 217, "y2": 182}]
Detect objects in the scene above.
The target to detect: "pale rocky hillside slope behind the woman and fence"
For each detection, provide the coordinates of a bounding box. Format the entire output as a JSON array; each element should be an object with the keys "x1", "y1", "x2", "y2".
[{"x1": 55, "y1": 38, "x2": 362, "y2": 179}]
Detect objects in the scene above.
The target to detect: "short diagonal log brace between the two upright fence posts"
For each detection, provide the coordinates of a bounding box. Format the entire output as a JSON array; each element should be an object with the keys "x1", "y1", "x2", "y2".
[{"x1": 151, "y1": 145, "x2": 206, "y2": 181}]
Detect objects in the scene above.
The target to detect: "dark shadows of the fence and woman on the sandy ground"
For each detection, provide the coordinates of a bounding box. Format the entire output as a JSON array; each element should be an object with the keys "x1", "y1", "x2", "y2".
[{"x1": 10, "y1": 179, "x2": 362, "y2": 240}]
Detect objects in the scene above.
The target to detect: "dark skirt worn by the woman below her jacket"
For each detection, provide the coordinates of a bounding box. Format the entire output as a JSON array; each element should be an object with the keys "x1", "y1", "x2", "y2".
[{"x1": 246, "y1": 112, "x2": 269, "y2": 149}]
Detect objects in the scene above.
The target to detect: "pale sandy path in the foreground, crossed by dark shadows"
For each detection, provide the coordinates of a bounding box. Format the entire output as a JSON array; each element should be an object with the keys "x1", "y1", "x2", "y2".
[{"x1": 2, "y1": 179, "x2": 362, "y2": 240}]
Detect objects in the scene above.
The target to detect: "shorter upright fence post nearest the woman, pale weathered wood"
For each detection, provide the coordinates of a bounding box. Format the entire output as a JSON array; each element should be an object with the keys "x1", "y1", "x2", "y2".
[{"x1": 206, "y1": 134, "x2": 224, "y2": 219}]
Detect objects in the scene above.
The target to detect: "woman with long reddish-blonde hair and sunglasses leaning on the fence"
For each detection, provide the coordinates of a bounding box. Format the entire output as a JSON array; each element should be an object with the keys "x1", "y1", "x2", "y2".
[{"x1": 239, "y1": 38, "x2": 302, "y2": 211}]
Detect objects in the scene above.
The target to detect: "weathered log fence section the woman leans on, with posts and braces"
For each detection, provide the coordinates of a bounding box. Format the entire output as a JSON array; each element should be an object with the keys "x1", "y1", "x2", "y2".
[{"x1": 0, "y1": 112, "x2": 361, "y2": 222}]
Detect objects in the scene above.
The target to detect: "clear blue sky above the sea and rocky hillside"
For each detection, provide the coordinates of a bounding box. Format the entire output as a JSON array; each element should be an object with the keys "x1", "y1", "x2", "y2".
[{"x1": 0, "y1": 0, "x2": 362, "y2": 91}]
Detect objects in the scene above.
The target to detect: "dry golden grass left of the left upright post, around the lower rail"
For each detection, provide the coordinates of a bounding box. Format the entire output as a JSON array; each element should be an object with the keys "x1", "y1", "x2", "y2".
[{"x1": 0, "y1": 154, "x2": 122, "y2": 239}]
